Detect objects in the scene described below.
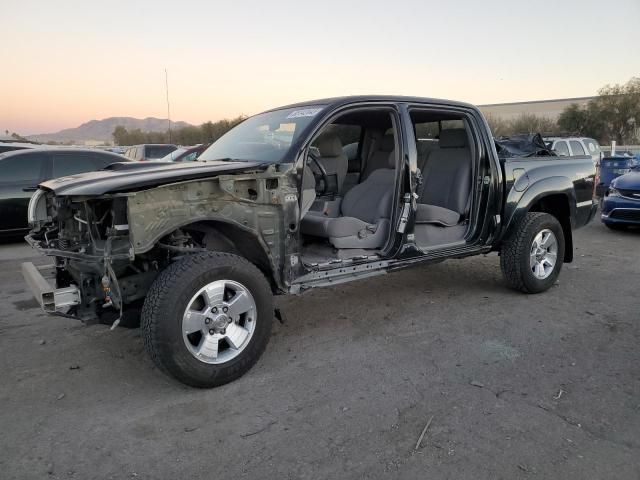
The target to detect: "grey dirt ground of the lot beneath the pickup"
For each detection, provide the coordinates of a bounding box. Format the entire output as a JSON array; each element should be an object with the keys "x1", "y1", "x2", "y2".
[{"x1": 0, "y1": 221, "x2": 640, "y2": 480}]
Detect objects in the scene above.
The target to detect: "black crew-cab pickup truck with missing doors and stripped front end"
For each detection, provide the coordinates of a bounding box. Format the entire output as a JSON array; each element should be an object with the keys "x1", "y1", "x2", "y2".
[{"x1": 23, "y1": 97, "x2": 596, "y2": 387}]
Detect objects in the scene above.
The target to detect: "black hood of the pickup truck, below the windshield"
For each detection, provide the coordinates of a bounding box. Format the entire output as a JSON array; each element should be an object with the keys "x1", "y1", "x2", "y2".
[{"x1": 40, "y1": 161, "x2": 267, "y2": 196}]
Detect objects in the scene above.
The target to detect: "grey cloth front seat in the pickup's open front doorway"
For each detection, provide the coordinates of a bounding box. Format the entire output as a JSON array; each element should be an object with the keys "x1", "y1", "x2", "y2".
[{"x1": 301, "y1": 153, "x2": 395, "y2": 248}]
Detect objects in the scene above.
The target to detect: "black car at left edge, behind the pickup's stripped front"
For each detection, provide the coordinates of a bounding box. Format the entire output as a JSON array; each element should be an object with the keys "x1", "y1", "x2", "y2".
[{"x1": 0, "y1": 148, "x2": 128, "y2": 236}]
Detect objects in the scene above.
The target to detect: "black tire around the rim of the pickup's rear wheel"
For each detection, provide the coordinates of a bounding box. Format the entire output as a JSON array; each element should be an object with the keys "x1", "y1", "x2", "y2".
[{"x1": 500, "y1": 212, "x2": 565, "y2": 293}]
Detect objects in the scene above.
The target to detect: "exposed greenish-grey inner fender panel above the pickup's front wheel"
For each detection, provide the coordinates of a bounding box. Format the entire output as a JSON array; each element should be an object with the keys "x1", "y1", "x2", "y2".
[{"x1": 128, "y1": 169, "x2": 297, "y2": 288}]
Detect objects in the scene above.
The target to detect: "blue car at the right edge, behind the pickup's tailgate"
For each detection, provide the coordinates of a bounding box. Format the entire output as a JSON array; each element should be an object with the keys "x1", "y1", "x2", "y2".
[{"x1": 602, "y1": 167, "x2": 640, "y2": 230}]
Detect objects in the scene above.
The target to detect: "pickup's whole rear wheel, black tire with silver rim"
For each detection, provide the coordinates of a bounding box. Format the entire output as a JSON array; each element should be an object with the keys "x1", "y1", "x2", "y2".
[{"x1": 500, "y1": 212, "x2": 564, "y2": 293}]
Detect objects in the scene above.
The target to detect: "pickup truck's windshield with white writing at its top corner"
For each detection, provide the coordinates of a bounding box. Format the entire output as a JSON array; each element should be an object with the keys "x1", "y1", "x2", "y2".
[{"x1": 198, "y1": 105, "x2": 323, "y2": 163}]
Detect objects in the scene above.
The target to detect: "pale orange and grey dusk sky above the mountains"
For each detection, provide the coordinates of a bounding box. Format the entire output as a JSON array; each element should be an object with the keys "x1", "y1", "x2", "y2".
[{"x1": 0, "y1": 0, "x2": 640, "y2": 135}]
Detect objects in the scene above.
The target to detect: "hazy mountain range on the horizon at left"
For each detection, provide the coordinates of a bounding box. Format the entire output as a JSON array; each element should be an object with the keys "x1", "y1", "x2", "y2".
[{"x1": 27, "y1": 117, "x2": 190, "y2": 143}]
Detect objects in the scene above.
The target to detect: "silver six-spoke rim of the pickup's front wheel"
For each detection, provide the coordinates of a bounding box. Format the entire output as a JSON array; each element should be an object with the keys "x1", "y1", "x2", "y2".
[{"x1": 182, "y1": 280, "x2": 257, "y2": 364}]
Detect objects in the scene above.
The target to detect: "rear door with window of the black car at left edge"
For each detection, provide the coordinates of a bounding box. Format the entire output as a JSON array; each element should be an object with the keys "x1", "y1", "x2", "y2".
[{"x1": 0, "y1": 151, "x2": 49, "y2": 231}]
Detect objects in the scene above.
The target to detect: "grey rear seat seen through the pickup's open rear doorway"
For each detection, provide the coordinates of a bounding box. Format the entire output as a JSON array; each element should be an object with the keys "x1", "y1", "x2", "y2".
[{"x1": 416, "y1": 128, "x2": 472, "y2": 227}]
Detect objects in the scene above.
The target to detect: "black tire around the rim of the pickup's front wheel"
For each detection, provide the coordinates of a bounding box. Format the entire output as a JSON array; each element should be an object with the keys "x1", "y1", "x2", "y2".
[{"x1": 141, "y1": 252, "x2": 274, "y2": 388}]
